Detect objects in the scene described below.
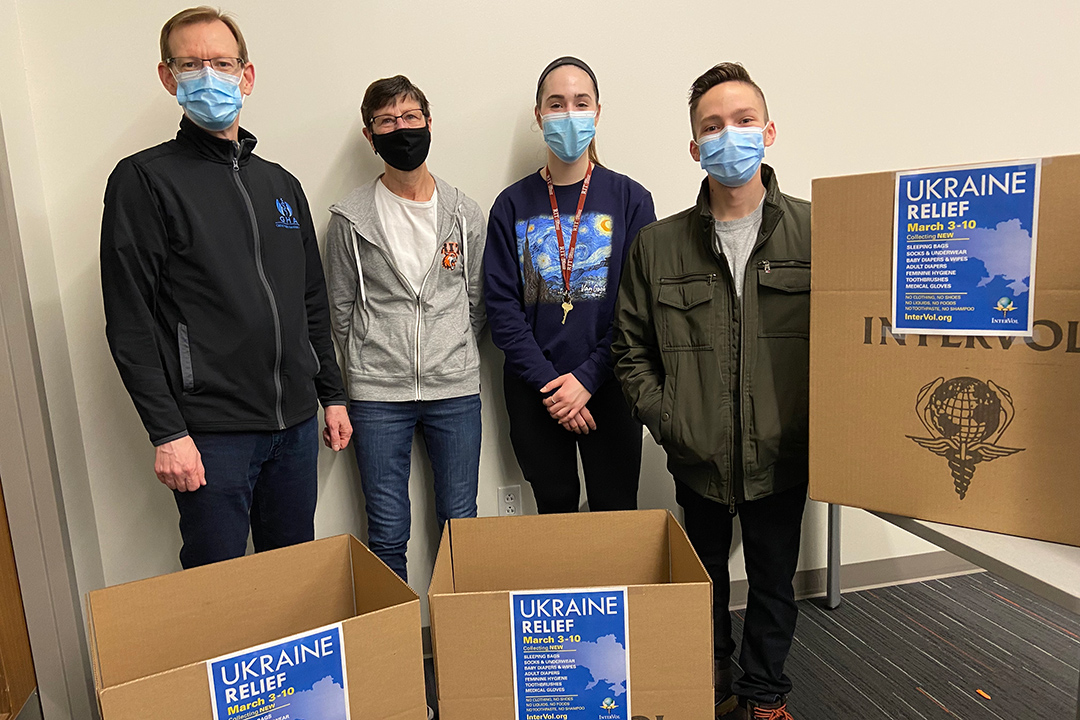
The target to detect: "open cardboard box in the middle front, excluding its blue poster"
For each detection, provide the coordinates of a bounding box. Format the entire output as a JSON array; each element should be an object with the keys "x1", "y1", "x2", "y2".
[{"x1": 428, "y1": 511, "x2": 713, "y2": 720}]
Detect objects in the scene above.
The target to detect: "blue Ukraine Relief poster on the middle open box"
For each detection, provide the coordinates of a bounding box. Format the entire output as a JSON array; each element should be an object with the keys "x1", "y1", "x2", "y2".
[{"x1": 510, "y1": 587, "x2": 631, "y2": 720}]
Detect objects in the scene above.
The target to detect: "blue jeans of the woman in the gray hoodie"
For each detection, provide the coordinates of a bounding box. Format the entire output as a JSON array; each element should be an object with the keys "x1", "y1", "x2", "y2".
[{"x1": 349, "y1": 395, "x2": 481, "y2": 582}]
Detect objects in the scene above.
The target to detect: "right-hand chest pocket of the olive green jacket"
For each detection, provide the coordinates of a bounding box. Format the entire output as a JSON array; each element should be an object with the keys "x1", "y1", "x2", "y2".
[{"x1": 757, "y1": 260, "x2": 810, "y2": 339}]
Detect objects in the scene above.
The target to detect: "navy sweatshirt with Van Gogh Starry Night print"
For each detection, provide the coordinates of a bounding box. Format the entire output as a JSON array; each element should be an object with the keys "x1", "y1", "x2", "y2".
[{"x1": 484, "y1": 165, "x2": 657, "y2": 393}]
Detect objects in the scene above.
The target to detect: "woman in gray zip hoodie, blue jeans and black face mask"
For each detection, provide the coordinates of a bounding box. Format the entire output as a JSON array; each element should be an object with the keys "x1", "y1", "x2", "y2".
[{"x1": 325, "y1": 76, "x2": 485, "y2": 582}]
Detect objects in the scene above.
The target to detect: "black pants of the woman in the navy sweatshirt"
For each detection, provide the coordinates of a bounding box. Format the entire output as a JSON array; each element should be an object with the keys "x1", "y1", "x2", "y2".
[{"x1": 503, "y1": 373, "x2": 642, "y2": 514}]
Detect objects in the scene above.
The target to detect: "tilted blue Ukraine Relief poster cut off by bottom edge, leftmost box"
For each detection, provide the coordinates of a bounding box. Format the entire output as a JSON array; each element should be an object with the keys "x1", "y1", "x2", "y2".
[{"x1": 206, "y1": 623, "x2": 349, "y2": 720}]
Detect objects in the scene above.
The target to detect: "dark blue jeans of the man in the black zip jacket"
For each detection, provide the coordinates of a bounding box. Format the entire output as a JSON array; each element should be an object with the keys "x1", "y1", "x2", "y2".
[{"x1": 173, "y1": 416, "x2": 319, "y2": 568}]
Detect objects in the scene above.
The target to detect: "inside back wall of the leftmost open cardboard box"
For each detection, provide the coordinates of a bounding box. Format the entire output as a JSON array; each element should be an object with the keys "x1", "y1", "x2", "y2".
[{"x1": 87, "y1": 535, "x2": 354, "y2": 690}]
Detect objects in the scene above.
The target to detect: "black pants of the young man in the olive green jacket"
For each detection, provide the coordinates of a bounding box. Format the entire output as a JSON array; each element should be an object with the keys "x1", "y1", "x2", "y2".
[{"x1": 675, "y1": 480, "x2": 807, "y2": 703}]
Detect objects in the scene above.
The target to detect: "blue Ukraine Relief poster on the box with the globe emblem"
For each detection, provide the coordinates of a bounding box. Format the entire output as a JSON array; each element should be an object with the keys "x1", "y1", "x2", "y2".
[{"x1": 892, "y1": 160, "x2": 1042, "y2": 337}]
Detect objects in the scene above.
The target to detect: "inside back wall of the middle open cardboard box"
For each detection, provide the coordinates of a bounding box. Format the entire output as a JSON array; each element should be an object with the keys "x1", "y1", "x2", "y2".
[{"x1": 440, "y1": 510, "x2": 671, "y2": 593}]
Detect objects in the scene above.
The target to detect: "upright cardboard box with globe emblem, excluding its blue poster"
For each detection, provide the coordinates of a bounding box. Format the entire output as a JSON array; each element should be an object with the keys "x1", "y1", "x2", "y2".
[{"x1": 810, "y1": 155, "x2": 1080, "y2": 545}]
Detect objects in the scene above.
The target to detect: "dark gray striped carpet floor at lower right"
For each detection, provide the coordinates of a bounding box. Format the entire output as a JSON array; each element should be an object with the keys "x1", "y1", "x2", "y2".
[{"x1": 732, "y1": 573, "x2": 1080, "y2": 720}]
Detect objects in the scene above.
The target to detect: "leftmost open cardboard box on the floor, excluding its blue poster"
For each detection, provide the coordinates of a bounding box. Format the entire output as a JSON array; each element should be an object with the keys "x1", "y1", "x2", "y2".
[{"x1": 86, "y1": 535, "x2": 428, "y2": 720}]
